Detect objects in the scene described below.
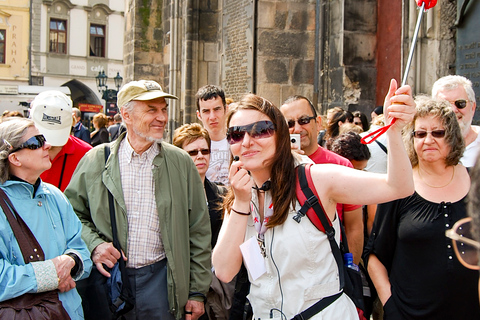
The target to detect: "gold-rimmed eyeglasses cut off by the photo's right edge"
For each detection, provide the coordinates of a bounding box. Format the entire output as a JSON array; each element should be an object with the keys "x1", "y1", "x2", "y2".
[{"x1": 445, "y1": 217, "x2": 480, "y2": 270}]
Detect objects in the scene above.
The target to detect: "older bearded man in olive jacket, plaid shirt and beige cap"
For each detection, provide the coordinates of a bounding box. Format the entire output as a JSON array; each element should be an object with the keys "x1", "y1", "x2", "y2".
[{"x1": 65, "y1": 80, "x2": 211, "y2": 320}]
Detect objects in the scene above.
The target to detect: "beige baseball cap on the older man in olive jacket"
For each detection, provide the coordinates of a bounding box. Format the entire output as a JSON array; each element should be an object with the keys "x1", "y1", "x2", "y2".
[{"x1": 117, "y1": 80, "x2": 178, "y2": 107}]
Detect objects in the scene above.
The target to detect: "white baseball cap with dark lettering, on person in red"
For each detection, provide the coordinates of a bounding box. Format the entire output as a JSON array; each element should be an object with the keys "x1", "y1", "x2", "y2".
[{"x1": 30, "y1": 90, "x2": 73, "y2": 146}]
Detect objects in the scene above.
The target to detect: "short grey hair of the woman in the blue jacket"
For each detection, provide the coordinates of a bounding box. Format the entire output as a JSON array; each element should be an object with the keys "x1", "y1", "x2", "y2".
[{"x1": 0, "y1": 117, "x2": 35, "y2": 183}]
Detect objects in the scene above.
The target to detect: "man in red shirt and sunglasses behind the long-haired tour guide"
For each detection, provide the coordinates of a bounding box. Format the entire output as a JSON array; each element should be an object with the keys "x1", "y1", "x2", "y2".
[{"x1": 280, "y1": 95, "x2": 363, "y2": 264}]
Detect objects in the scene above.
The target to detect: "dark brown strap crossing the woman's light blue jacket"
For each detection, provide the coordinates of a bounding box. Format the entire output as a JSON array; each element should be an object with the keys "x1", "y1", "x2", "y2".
[{"x1": 0, "y1": 188, "x2": 45, "y2": 263}]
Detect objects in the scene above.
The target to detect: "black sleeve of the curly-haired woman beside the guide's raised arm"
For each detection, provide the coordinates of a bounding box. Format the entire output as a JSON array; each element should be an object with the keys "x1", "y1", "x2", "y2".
[{"x1": 364, "y1": 200, "x2": 401, "y2": 273}]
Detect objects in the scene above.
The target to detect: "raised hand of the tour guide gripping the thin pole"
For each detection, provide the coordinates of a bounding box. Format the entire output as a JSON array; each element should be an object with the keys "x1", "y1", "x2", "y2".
[{"x1": 384, "y1": 79, "x2": 416, "y2": 131}]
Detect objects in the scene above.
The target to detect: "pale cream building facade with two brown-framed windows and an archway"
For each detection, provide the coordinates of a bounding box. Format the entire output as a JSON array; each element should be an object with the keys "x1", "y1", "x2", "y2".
[{"x1": 0, "y1": 0, "x2": 125, "y2": 117}]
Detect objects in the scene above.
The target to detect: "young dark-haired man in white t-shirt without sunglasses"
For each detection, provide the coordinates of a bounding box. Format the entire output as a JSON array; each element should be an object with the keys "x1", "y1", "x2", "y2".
[{"x1": 195, "y1": 84, "x2": 230, "y2": 185}]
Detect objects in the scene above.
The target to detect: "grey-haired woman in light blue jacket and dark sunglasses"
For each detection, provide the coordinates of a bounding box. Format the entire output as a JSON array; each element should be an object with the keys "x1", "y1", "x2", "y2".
[{"x1": 0, "y1": 118, "x2": 92, "y2": 319}]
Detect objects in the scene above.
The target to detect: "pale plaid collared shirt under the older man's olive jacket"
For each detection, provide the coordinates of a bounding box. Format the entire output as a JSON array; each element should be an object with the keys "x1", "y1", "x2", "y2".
[{"x1": 118, "y1": 138, "x2": 165, "y2": 268}]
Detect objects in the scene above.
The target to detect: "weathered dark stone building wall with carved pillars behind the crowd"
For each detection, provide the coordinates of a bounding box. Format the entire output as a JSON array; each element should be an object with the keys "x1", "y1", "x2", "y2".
[{"x1": 124, "y1": 0, "x2": 464, "y2": 141}]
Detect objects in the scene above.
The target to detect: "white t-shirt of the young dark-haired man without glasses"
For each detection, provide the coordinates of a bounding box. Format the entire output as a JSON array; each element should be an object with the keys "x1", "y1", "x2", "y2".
[{"x1": 206, "y1": 138, "x2": 230, "y2": 186}]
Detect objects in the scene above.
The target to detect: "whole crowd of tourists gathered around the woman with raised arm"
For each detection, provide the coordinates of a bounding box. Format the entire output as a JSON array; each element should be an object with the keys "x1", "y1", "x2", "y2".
[{"x1": 0, "y1": 76, "x2": 480, "y2": 320}]
